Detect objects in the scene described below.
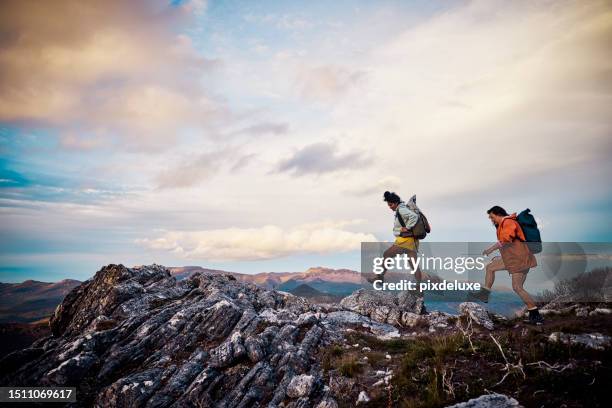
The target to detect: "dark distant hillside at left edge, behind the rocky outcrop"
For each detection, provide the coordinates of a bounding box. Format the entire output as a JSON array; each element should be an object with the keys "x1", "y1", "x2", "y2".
[{"x1": 0, "y1": 279, "x2": 81, "y2": 323}]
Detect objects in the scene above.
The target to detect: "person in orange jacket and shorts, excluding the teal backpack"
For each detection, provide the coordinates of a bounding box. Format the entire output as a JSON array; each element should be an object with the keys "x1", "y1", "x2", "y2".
[{"x1": 469, "y1": 205, "x2": 544, "y2": 325}]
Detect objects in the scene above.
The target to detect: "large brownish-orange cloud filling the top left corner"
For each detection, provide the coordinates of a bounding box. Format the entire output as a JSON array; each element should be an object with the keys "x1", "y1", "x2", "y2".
[{"x1": 0, "y1": 0, "x2": 222, "y2": 148}]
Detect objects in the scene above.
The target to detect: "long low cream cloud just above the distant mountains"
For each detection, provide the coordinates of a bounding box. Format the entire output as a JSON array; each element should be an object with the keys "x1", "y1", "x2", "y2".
[{"x1": 137, "y1": 221, "x2": 376, "y2": 262}]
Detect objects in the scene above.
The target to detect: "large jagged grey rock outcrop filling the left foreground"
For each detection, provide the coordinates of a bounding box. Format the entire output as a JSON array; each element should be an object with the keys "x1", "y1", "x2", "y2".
[{"x1": 0, "y1": 265, "x2": 407, "y2": 408}]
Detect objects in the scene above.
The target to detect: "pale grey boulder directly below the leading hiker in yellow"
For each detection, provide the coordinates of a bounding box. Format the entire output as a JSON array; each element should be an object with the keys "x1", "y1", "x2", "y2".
[{"x1": 340, "y1": 289, "x2": 423, "y2": 326}]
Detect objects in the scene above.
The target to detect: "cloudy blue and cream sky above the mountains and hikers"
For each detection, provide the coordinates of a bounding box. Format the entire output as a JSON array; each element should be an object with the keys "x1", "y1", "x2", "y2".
[{"x1": 0, "y1": 0, "x2": 612, "y2": 282}]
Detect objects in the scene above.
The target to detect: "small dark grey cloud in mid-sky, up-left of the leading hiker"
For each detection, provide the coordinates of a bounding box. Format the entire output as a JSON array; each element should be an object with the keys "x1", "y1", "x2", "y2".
[{"x1": 278, "y1": 143, "x2": 372, "y2": 175}]
